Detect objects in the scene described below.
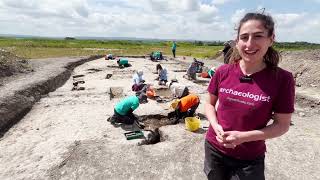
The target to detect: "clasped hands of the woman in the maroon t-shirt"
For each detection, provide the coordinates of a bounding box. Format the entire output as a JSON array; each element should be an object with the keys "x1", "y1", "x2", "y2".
[{"x1": 217, "y1": 131, "x2": 244, "y2": 148}]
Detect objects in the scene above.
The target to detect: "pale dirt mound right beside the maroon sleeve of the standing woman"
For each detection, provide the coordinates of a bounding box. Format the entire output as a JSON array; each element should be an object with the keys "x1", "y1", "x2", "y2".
[{"x1": 280, "y1": 49, "x2": 320, "y2": 89}]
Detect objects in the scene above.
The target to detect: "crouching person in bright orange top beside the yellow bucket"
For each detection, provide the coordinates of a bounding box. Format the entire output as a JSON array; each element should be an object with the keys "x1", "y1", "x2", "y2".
[{"x1": 171, "y1": 94, "x2": 200, "y2": 122}]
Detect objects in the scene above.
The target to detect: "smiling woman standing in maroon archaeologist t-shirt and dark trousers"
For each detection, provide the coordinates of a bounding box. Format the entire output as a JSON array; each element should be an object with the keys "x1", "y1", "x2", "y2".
[{"x1": 204, "y1": 13, "x2": 295, "y2": 180}]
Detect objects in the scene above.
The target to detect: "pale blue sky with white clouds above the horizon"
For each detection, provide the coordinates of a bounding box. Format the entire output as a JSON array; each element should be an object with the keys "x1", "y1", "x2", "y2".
[{"x1": 0, "y1": 0, "x2": 320, "y2": 43}]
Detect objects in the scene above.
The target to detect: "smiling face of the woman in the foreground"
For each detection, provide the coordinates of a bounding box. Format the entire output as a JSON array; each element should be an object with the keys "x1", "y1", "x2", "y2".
[{"x1": 237, "y1": 20, "x2": 274, "y2": 63}]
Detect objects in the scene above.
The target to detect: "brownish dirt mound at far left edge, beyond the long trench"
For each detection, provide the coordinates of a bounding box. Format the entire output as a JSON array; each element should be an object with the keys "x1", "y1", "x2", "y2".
[{"x1": 0, "y1": 49, "x2": 32, "y2": 78}]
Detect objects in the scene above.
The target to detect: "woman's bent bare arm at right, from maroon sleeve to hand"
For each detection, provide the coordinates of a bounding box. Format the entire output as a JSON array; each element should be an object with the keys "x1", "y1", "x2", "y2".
[{"x1": 219, "y1": 113, "x2": 292, "y2": 148}]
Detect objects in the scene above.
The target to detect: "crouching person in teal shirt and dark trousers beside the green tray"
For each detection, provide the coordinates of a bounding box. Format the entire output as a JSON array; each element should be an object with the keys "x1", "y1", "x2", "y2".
[{"x1": 108, "y1": 94, "x2": 148, "y2": 125}]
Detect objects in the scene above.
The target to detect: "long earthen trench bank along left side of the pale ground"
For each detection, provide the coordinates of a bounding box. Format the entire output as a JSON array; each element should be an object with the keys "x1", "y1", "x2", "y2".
[{"x1": 0, "y1": 55, "x2": 102, "y2": 136}]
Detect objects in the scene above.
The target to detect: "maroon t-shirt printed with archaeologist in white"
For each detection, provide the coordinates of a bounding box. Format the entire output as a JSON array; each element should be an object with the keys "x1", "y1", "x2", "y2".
[{"x1": 206, "y1": 63, "x2": 295, "y2": 160}]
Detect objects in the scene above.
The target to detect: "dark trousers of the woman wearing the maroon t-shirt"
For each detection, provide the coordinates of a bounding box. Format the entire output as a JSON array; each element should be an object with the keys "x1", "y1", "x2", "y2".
[{"x1": 204, "y1": 140, "x2": 265, "y2": 180}]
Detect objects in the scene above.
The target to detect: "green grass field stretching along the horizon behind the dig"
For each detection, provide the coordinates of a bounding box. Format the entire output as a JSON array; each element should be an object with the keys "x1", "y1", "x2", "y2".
[{"x1": 0, "y1": 38, "x2": 320, "y2": 59}]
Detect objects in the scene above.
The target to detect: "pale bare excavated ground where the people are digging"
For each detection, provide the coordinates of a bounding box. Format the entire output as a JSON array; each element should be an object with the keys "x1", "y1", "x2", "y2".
[{"x1": 0, "y1": 55, "x2": 320, "y2": 180}]
